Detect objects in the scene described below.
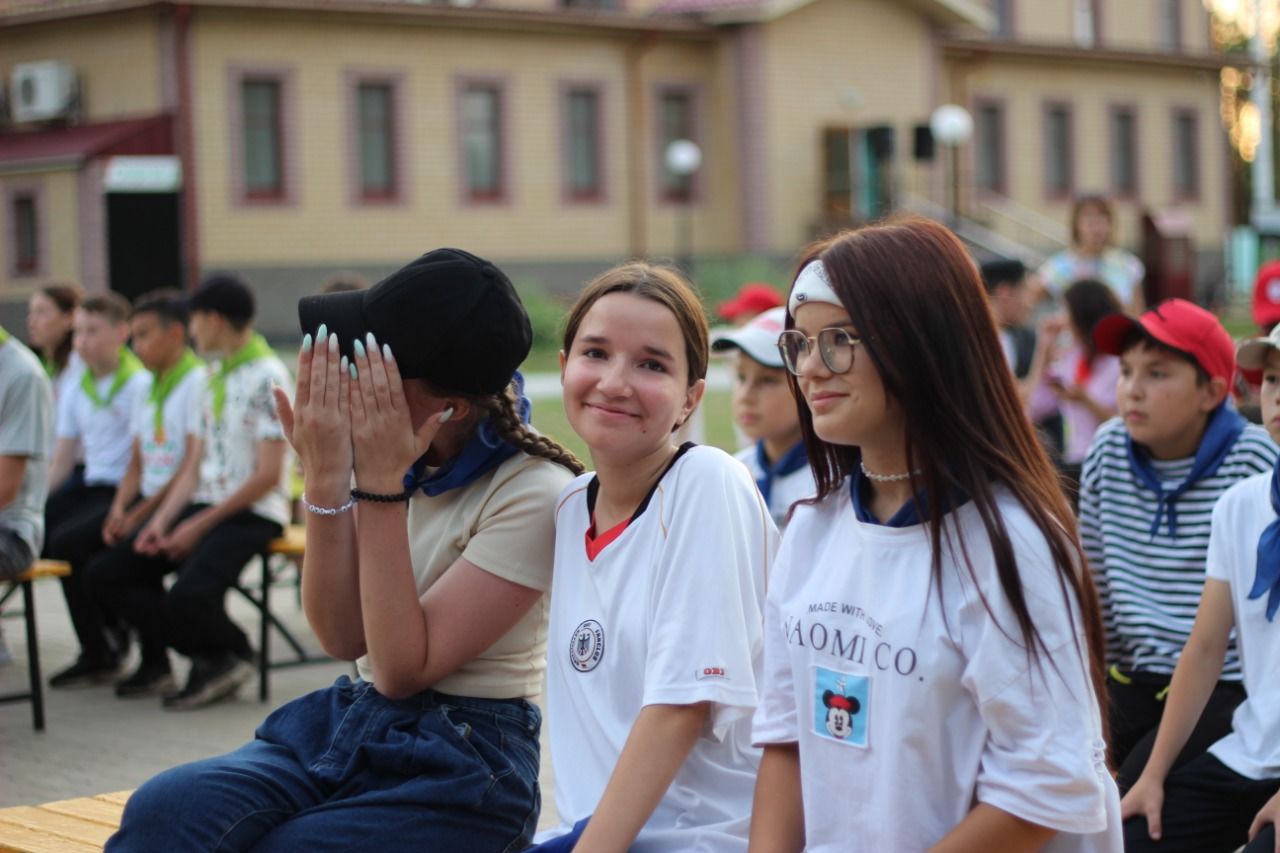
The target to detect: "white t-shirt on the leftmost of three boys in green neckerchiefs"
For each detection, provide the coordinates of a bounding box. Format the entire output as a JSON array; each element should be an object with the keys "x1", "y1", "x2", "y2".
[{"x1": 54, "y1": 356, "x2": 151, "y2": 485}]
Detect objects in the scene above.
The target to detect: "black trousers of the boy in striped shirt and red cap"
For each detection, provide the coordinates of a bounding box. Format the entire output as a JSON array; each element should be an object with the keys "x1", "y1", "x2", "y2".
[{"x1": 1107, "y1": 672, "x2": 1244, "y2": 797}]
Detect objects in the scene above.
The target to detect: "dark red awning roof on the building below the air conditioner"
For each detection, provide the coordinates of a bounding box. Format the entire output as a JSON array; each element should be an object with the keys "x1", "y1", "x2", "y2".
[{"x1": 0, "y1": 115, "x2": 174, "y2": 170}]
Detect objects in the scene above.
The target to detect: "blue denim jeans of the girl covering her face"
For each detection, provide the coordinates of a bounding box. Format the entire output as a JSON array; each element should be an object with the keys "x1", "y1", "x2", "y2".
[{"x1": 106, "y1": 676, "x2": 541, "y2": 853}]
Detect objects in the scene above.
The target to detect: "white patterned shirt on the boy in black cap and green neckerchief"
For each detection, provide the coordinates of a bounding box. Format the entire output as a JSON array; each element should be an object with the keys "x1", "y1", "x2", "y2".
[{"x1": 195, "y1": 356, "x2": 293, "y2": 525}]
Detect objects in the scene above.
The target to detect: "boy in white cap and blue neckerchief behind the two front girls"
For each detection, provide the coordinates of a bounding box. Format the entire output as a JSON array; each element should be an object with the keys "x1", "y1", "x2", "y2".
[{"x1": 712, "y1": 307, "x2": 817, "y2": 530}]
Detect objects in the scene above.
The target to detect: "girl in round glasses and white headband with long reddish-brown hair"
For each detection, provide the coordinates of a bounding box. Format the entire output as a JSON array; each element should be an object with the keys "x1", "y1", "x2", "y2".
[{"x1": 751, "y1": 220, "x2": 1121, "y2": 853}]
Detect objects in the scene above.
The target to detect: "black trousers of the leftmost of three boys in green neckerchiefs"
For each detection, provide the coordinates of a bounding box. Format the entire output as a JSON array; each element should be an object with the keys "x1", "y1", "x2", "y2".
[{"x1": 45, "y1": 485, "x2": 116, "y2": 662}]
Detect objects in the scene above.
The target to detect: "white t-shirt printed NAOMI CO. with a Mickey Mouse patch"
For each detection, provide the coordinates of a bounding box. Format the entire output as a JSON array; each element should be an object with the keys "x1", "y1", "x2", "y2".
[{"x1": 754, "y1": 482, "x2": 1123, "y2": 853}]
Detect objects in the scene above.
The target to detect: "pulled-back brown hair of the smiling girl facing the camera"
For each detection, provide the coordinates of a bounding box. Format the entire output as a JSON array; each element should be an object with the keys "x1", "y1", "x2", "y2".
[{"x1": 564, "y1": 261, "x2": 710, "y2": 386}]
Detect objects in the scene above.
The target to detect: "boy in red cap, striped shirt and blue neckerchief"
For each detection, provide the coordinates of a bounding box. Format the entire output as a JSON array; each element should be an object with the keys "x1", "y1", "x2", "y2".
[{"x1": 1080, "y1": 300, "x2": 1277, "y2": 793}]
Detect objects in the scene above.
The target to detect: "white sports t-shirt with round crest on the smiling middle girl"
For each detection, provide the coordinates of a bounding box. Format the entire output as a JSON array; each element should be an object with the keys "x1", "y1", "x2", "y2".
[{"x1": 548, "y1": 447, "x2": 777, "y2": 853}]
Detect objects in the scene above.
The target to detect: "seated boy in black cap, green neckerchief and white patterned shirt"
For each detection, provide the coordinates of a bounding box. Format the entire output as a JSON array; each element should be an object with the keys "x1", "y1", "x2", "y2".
[{"x1": 95, "y1": 275, "x2": 293, "y2": 710}]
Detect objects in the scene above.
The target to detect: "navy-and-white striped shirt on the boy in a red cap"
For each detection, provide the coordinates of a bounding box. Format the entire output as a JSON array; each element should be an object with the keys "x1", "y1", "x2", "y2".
[{"x1": 1080, "y1": 418, "x2": 1280, "y2": 681}]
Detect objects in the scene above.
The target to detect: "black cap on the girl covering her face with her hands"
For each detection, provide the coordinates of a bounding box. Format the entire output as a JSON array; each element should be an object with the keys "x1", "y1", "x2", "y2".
[{"x1": 298, "y1": 248, "x2": 534, "y2": 394}]
